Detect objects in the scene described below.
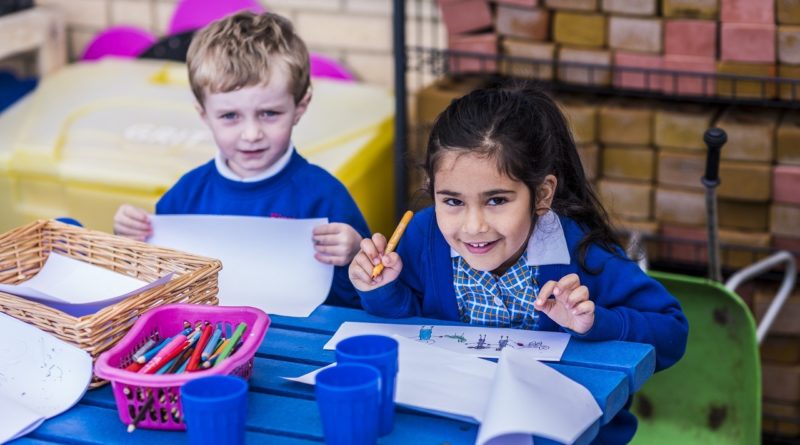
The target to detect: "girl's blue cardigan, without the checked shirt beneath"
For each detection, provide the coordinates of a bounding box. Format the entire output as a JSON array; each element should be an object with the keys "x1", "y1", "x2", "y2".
[{"x1": 359, "y1": 208, "x2": 689, "y2": 444}]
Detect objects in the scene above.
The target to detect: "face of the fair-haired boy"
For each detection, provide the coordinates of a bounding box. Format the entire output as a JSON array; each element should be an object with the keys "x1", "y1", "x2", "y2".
[{"x1": 198, "y1": 67, "x2": 311, "y2": 178}]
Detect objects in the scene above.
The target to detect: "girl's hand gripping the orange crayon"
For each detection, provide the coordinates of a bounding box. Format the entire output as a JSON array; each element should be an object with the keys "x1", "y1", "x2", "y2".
[{"x1": 349, "y1": 233, "x2": 403, "y2": 292}]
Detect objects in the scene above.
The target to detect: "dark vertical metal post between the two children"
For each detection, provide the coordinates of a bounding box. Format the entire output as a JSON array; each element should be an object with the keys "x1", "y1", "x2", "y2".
[{"x1": 392, "y1": 0, "x2": 408, "y2": 221}]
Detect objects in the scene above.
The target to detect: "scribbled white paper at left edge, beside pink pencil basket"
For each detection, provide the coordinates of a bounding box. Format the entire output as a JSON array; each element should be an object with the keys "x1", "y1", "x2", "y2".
[{"x1": 0, "y1": 314, "x2": 92, "y2": 443}]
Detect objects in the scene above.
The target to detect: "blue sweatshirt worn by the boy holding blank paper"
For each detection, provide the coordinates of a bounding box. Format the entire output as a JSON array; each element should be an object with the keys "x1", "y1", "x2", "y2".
[{"x1": 156, "y1": 151, "x2": 370, "y2": 307}]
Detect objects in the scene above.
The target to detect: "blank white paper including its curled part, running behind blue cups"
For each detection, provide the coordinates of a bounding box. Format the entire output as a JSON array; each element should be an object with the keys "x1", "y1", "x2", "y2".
[{"x1": 287, "y1": 335, "x2": 602, "y2": 445}]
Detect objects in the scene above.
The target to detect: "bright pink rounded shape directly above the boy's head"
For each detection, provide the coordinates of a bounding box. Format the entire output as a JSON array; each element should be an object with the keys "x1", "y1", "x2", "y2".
[{"x1": 168, "y1": 0, "x2": 265, "y2": 35}]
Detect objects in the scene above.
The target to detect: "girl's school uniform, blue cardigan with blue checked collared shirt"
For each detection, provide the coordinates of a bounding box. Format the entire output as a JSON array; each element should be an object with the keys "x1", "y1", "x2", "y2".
[{"x1": 359, "y1": 208, "x2": 688, "y2": 444}]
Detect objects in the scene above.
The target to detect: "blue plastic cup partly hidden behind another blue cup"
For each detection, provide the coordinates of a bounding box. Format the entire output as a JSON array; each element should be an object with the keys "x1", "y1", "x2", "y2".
[{"x1": 336, "y1": 335, "x2": 398, "y2": 436}]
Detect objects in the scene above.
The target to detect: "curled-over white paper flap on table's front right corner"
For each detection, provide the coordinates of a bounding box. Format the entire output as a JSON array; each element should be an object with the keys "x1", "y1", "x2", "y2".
[{"x1": 475, "y1": 349, "x2": 603, "y2": 445}]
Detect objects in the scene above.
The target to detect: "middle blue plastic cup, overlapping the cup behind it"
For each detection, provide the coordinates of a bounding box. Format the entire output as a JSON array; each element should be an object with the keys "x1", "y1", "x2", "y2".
[{"x1": 316, "y1": 363, "x2": 381, "y2": 445}]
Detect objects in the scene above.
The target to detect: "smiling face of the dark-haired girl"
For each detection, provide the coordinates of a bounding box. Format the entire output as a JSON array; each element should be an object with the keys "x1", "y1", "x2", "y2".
[{"x1": 433, "y1": 151, "x2": 536, "y2": 275}]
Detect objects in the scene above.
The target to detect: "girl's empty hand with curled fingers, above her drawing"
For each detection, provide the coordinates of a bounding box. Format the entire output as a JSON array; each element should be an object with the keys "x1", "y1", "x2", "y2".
[{"x1": 533, "y1": 273, "x2": 594, "y2": 334}]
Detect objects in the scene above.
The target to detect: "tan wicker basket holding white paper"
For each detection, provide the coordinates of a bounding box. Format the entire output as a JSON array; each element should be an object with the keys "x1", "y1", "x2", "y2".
[{"x1": 0, "y1": 220, "x2": 222, "y2": 387}]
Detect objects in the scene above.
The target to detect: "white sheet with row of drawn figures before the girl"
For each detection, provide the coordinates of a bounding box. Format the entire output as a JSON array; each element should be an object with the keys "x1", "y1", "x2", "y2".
[{"x1": 325, "y1": 321, "x2": 570, "y2": 361}]
